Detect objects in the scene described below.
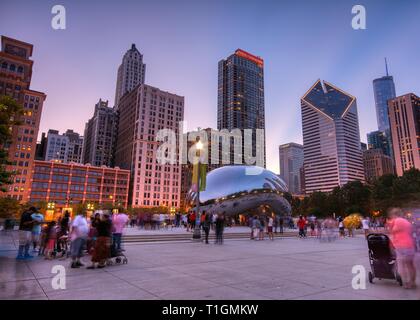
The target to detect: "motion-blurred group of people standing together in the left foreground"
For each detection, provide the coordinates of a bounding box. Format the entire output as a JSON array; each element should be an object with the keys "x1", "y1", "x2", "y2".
[{"x1": 16, "y1": 207, "x2": 129, "y2": 269}]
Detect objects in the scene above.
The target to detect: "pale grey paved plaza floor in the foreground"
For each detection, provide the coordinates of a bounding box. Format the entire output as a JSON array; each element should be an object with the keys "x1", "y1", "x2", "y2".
[{"x1": 0, "y1": 233, "x2": 420, "y2": 300}]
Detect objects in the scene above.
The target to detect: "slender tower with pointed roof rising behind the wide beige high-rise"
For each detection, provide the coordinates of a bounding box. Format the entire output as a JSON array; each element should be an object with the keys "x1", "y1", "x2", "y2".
[{"x1": 114, "y1": 43, "x2": 146, "y2": 107}]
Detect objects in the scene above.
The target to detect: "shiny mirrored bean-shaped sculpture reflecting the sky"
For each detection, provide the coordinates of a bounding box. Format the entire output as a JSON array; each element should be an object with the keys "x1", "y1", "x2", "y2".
[{"x1": 187, "y1": 165, "x2": 291, "y2": 216}]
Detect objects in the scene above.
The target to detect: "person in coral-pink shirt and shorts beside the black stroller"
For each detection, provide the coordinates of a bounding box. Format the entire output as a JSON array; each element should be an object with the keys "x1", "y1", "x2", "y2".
[{"x1": 387, "y1": 208, "x2": 416, "y2": 289}]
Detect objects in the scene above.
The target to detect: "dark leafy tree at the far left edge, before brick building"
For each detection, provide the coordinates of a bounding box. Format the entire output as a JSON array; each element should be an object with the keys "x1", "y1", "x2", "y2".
[{"x1": 0, "y1": 96, "x2": 23, "y2": 192}]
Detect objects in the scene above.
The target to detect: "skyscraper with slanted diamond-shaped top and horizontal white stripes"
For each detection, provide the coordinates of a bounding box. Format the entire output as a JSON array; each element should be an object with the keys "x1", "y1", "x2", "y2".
[{"x1": 301, "y1": 80, "x2": 364, "y2": 193}]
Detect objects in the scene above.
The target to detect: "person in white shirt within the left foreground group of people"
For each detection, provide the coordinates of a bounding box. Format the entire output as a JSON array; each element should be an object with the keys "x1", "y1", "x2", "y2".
[{"x1": 70, "y1": 212, "x2": 89, "y2": 268}]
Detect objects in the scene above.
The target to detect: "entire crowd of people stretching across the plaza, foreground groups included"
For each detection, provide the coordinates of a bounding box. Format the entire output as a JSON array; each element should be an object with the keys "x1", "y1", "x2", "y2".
[{"x1": 4, "y1": 207, "x2": 420, "y2": 288}]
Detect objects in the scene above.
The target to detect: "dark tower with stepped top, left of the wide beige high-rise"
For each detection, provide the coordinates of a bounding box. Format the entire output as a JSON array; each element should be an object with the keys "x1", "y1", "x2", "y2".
[{"x1": 82, "y1": 99, "x2": 117, "y2": 167}]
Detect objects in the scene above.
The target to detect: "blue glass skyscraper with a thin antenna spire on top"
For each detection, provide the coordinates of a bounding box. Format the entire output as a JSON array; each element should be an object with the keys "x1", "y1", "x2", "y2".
[{"x1": 373, "y1": 59, "x2": 396, "y2": 157}]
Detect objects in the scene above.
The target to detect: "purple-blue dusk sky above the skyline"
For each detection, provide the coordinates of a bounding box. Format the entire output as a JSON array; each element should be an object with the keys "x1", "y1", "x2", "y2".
[{"x1": 0, "y1": 0, "x2": 420, "y2": 173}]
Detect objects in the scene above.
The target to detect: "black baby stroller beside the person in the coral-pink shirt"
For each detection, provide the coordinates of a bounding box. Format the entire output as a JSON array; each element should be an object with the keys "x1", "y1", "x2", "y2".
[{"x1": 367, "y1": 234, "x2": 402, "y2": 286}]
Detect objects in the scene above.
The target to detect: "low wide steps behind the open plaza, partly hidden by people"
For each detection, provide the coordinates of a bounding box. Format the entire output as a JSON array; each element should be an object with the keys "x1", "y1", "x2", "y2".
[{"x1": 123, "y1": 232, "x2": 297, "y2": 243}]
